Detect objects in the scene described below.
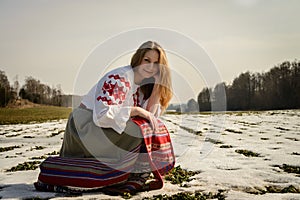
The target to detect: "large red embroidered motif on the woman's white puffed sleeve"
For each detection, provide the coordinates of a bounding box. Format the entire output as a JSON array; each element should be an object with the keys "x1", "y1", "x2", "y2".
[{"x1": 97, "y1": 74, "x2": 130, "y2": 105}]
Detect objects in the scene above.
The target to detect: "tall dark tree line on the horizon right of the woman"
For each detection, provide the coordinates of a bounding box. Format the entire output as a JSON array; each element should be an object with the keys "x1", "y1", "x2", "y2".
[{"x1": 198, "y1": 61, "x2": 300, "y2": 111}]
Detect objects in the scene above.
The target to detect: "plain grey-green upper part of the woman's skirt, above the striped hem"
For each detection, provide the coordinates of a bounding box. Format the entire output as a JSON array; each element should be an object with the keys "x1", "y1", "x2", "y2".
[{"x1": 60, "y1": 108, "x2": 143, "y2": 162}]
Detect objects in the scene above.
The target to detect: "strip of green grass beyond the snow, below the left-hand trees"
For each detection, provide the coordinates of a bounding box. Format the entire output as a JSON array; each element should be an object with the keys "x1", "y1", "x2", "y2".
[{"x1": 0, "y1": 106, "x2": 72, "y2": 125}]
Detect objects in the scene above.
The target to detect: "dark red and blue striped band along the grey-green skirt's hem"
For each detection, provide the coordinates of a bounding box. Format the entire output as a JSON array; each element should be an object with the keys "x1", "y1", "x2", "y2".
[{"x1": 38, "y1": 144, "x2": 139, "y2": 188}]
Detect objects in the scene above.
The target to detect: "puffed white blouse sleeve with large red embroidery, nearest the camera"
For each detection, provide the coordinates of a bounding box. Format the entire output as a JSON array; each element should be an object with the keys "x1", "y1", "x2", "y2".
[{"x1": 93, "y1": 75, "x2": 131, "y2": 134}]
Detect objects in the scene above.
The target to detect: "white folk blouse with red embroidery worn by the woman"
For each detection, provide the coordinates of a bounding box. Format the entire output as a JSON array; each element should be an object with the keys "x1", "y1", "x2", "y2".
[{"x1": 81, "y1": 66, "x2": 161, "y2": 134}]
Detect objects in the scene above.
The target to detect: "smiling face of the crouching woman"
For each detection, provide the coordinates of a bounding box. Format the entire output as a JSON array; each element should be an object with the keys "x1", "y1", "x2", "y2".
[{"x1": 137, "y1": 50, "x2": 159, "y2": 79}]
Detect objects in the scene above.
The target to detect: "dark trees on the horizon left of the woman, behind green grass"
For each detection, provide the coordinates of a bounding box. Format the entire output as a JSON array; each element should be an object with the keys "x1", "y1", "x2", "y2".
[{"x1": 0, "y1": 70, "x2": 64, "y2": 107}]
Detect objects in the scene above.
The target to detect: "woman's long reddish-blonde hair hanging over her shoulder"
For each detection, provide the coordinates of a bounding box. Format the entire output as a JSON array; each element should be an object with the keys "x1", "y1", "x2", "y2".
[{"x1": 130, "y1": 41, "x2": 173, "y2": 111}]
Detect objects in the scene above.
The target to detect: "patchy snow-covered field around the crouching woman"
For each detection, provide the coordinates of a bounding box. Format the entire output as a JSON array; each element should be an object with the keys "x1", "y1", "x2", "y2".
[{"x1": 0, "y1": 110, "x2": 300, "y2": 200}]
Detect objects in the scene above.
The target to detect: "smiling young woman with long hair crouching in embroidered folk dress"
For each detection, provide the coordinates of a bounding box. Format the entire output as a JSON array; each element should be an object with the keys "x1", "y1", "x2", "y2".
[{"x1": 35, "y1": 41, "x2": 175, "y2": 195}]
